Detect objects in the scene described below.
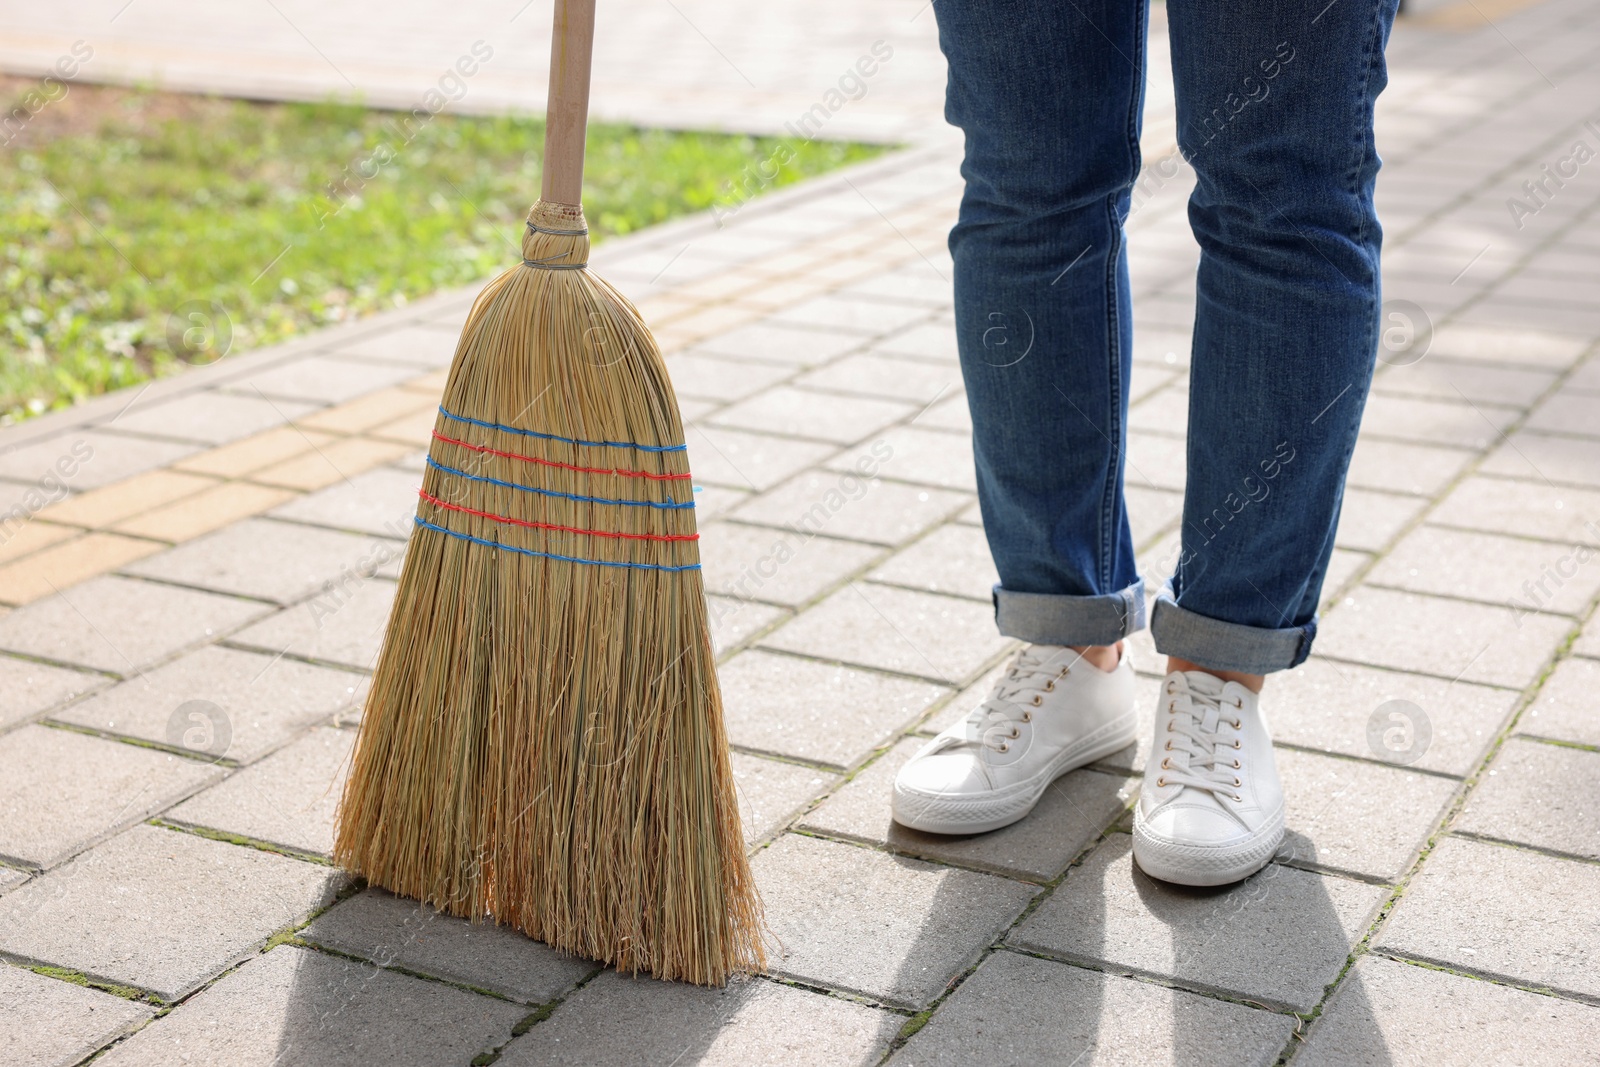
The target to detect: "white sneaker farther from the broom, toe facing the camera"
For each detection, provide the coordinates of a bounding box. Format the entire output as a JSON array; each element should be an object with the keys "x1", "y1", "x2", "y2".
[{"x1": 1133, "y1": 670, "x2": 1283, "y2": 886}]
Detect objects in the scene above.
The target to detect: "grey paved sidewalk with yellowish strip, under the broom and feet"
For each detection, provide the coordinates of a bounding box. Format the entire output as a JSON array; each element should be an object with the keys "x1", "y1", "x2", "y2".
[{"x1": 0, "y1": 0, "x2": 1600, "y2": 1067}]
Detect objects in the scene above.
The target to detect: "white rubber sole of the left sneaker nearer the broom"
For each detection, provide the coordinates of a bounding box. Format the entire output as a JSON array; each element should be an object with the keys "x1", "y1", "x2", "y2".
[{"x1": 894, "y1": 712, "x2": 1139, "y2": 835}]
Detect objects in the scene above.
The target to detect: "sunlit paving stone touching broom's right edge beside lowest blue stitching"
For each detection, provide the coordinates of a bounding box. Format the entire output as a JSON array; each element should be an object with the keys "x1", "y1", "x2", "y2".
[{"x1": 699, "y1": 523, "x2": 883, "y2": 606}]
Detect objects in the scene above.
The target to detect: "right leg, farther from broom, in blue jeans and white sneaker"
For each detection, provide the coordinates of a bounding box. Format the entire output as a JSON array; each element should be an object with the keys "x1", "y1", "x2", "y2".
[{"x1": 1133, "y1": 0, "x2": 1395, "y2": 885}]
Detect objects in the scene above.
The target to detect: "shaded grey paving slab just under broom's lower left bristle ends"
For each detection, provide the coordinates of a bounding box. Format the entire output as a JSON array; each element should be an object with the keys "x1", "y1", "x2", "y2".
[{"x1": 301, "y1": 889, "x2": 598, "y2": 1005}]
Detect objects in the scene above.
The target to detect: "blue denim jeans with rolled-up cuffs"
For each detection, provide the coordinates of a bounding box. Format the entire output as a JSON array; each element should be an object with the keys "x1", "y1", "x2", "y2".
[{"x1": 934, "y1": 0, "x2": 1395, "y2": 673}]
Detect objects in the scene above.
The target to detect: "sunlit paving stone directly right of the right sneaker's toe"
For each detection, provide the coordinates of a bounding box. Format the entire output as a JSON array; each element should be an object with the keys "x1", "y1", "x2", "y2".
[{"x1": 1275, "y1": 749, "x2": 1458, "y2": 881}]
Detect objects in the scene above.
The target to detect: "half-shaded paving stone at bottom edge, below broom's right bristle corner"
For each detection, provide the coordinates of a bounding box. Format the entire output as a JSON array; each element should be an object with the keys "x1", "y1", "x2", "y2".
[{"x1": 498, "y1": 973, "x2": 904, "y2": 1067}]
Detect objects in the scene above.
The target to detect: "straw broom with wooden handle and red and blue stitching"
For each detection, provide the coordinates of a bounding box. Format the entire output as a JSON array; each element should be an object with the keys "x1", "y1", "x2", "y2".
[{"x1": 334, "y1": 0, "x2": 763, "y2": 985}]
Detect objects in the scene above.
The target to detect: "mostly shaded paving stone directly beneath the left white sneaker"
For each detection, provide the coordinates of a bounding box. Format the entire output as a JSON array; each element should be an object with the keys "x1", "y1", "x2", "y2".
[{"x1": 802, "y1": 737, "x2": 1138, "y2": 883}]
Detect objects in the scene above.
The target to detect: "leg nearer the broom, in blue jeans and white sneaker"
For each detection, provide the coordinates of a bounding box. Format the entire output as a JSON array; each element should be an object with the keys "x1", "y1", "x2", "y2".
[{"x1": 894, "y1": 0, "x2": 1146, "y2": 833}]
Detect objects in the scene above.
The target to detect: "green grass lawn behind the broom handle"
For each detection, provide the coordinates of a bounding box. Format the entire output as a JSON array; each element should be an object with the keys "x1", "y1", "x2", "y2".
[{"x1": 0, "y1": 78, "x2": 882, "y2": 424}]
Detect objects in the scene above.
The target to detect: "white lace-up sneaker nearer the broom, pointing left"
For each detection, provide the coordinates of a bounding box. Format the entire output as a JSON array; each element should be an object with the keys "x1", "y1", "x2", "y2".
[{"x1": 894, "y1": 645, "x2": 1138, "y2": 833}]
